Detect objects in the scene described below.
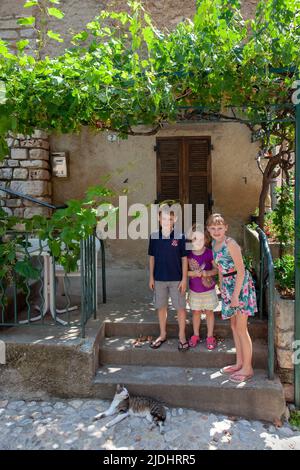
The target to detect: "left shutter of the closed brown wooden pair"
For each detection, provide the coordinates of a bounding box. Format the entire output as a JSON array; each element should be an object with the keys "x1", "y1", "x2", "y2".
[{"x1": 157, "y1": 138, "x2": 182, "y2": 202}]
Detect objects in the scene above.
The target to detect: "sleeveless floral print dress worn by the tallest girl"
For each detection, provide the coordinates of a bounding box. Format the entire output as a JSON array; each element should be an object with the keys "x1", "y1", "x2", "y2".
[{"x1": 212, "y1": 238, "x2": 257, "y2": 320}]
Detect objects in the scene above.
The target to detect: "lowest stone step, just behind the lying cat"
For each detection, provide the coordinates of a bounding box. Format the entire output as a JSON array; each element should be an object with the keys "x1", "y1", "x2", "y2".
[{"x1": 93, "y1": 364, "x2": 285, "y2": 422}]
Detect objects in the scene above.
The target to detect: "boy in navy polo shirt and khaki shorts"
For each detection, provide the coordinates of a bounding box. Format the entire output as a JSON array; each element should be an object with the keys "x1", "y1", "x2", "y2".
[{"x1": 148, "y1": 204, "x2": 189, "y2": 351}]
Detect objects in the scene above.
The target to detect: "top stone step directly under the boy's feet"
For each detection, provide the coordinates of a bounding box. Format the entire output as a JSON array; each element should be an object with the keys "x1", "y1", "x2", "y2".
[{"x1": 105, "y1": 312, "x2": 268, "y2": 340}]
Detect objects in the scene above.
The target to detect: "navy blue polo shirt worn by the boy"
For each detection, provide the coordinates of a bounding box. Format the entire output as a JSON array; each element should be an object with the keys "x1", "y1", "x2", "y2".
[{"x1": 148, "y1": 230, "x2": 187, "y2": 281}]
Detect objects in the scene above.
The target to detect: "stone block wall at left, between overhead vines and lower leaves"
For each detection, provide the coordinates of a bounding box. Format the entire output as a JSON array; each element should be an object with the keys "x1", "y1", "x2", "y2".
[{"x1": 0, "y1": 131, "x2": 52, "y2": 218}]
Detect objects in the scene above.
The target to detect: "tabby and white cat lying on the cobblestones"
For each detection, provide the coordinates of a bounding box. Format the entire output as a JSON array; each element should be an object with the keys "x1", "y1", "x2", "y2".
[{"x1": 94, "y1": 385, "x2": 166, "y2": 434}]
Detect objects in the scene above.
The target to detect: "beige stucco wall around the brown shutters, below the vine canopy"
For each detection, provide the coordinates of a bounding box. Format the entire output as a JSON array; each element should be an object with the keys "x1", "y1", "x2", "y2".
[{"x1": 50, "y1": 123, "x2": 261, "y2": 265}]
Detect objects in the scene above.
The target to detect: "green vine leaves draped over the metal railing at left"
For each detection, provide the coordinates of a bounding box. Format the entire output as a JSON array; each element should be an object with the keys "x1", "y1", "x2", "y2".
[{"x1": 0, "y1": 185, "x2": 115, "y2": 286}]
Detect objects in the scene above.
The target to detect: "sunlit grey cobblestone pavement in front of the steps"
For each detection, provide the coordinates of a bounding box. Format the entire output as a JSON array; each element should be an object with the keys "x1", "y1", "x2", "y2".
[{"x1": 0, "y1": 400, "x2": 300, "y2": 450}]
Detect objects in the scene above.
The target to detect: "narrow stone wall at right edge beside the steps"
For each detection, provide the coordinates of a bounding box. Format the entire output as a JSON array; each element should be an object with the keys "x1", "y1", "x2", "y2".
[{"x1": 275, "y1": 292, "x2": 295, "y2": 402}]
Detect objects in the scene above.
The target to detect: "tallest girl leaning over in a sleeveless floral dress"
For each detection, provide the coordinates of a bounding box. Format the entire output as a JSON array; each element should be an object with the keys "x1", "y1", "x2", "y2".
[{"x1": 207, "y1": 214, "x2": 257, "y2": 383}]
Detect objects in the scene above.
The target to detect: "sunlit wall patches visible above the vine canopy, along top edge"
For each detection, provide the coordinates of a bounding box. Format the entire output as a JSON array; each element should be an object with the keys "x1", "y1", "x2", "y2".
[{"x1": 0, "y1": 0, "x2": 258, "y2": 55}]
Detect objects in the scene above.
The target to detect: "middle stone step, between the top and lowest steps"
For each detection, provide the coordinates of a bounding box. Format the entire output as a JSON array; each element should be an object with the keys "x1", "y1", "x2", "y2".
[{"x1": 99, "y1": 336, "x2": 268, "y2": 369}]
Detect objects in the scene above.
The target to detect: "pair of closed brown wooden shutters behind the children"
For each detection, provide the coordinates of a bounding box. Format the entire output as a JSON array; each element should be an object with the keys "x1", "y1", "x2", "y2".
[{"x1": 156, "y1": 137, "x2": 212, "y2": 221}]
